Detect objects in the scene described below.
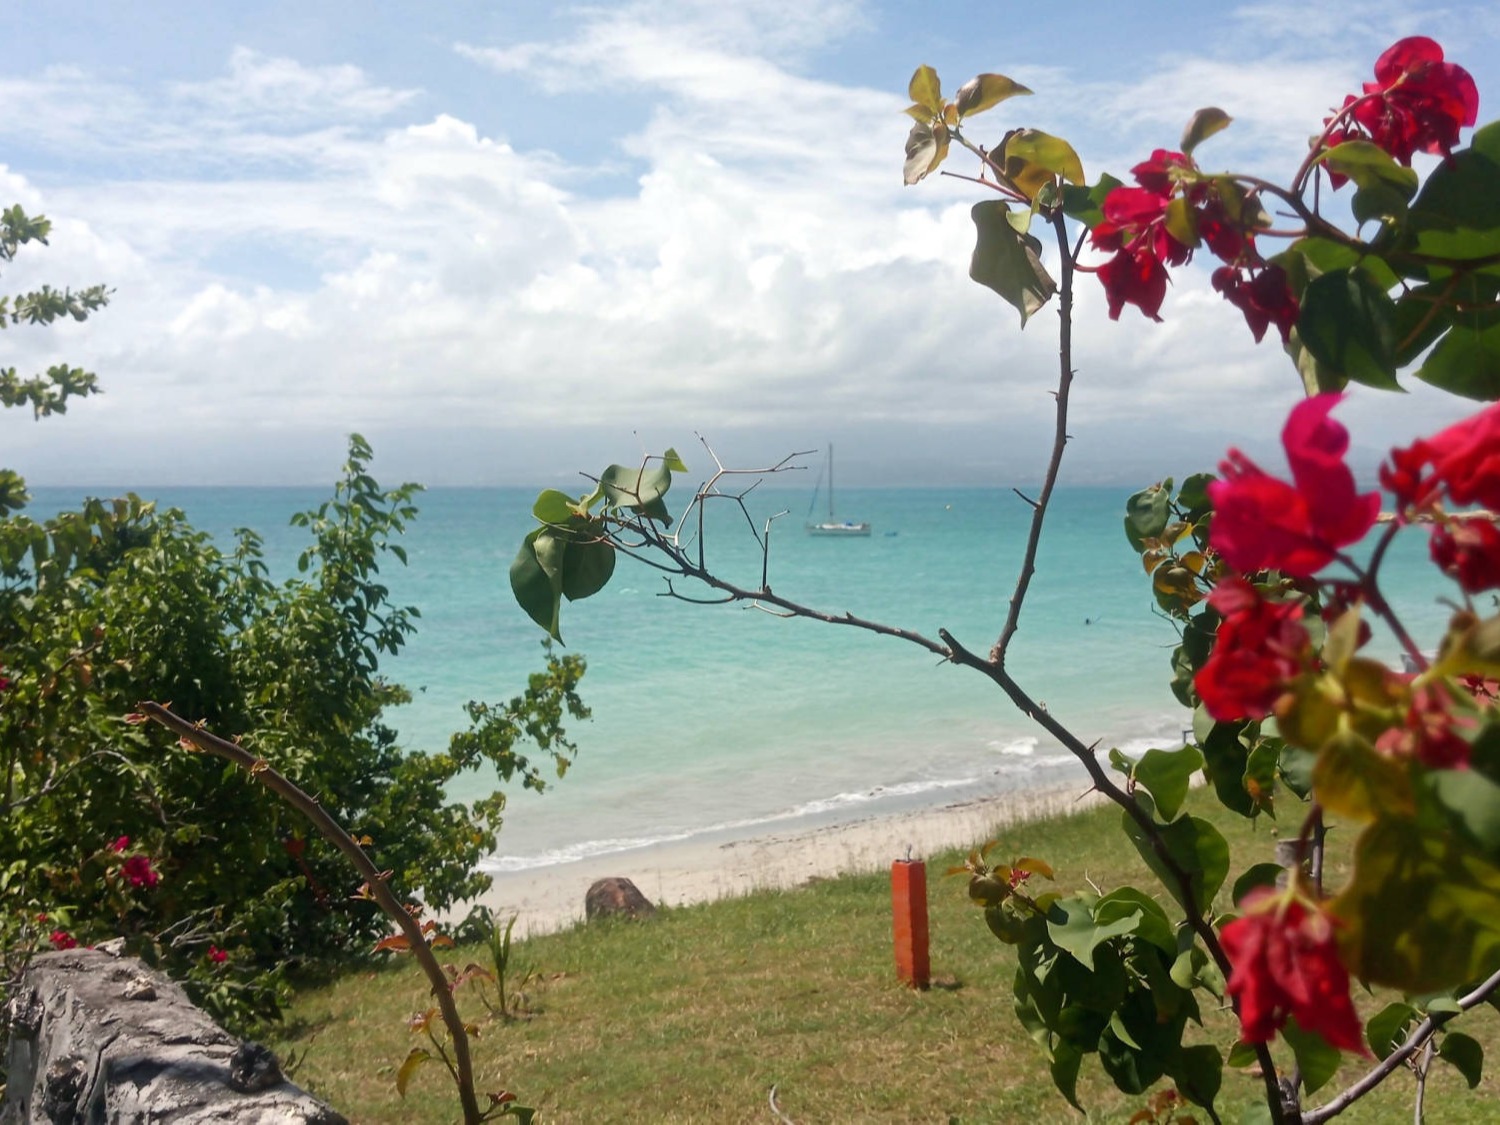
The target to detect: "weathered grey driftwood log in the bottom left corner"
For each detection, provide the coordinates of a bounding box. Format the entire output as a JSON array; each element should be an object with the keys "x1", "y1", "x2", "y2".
[{"x1": 0, "y1": 948, "x2": 347, "y2": 1125}]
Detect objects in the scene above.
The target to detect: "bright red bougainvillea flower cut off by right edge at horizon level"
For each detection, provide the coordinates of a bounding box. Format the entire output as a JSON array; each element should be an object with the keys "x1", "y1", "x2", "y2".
[{"x1": 1380, "y1": 402, "x2": 1500, "y2": 509}]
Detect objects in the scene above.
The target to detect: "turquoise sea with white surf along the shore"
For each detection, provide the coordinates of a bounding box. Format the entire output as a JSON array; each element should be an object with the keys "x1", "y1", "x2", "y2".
[{"x1": 30, "y1": 488, "x2": 1448, "y2": 870}]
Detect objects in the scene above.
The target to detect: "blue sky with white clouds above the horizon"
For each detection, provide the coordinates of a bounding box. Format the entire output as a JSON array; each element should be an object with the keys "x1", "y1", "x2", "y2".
[{"x1": 0, "y1": 0, "x2": 1500, "y2": 488}]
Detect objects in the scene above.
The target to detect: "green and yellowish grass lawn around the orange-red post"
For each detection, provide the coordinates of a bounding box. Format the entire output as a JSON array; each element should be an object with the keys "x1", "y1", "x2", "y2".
[{"x1": 275, "y1": 792, "x2": 1500, "y2": 1125}]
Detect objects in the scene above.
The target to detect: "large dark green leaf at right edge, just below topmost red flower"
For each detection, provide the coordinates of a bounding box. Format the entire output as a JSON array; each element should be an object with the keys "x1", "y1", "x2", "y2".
[{"x1": 1409, "y1": 122, "x2": 1500, "y2": 261}]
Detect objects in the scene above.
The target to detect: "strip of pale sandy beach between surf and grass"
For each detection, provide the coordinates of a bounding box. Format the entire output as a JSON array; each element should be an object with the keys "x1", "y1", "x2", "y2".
[{"x1": 455, "y1": 786, "x2": 1103, "y2": 936}]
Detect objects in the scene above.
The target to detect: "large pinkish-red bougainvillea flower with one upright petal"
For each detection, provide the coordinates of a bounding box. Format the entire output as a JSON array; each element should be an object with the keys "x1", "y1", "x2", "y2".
[{"x1": 1209, "y1": 395, "x2": 1380, "y2": 578}]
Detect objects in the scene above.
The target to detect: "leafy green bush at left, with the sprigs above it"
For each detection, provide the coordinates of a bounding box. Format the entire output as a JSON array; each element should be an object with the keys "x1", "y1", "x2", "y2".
[{"x1": 0, "y1": 209, "x2": 588, "y2": 1023}]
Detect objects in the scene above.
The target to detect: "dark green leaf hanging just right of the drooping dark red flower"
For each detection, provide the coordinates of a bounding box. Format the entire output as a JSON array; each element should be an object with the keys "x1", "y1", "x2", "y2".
[{"x1": 1298, "y1": 269, "x2": 1401, "y2": 390}]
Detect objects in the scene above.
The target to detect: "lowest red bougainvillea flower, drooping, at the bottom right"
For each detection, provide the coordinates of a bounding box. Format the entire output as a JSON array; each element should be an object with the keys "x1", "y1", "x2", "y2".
[{"x1": 1220, "y1": 887, "x2": 1370, "y2": 1055}]
